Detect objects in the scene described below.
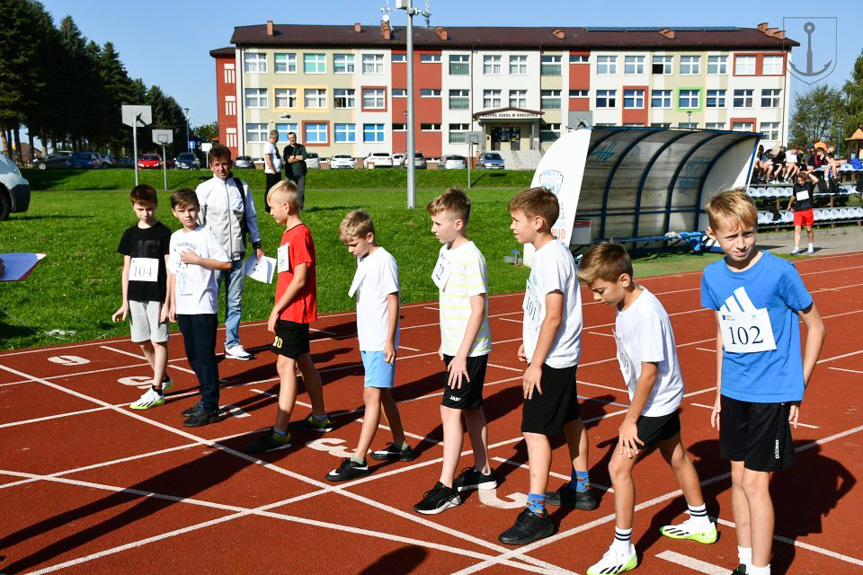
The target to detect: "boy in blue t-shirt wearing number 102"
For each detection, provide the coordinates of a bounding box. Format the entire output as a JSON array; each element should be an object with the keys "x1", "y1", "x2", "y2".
[{"x1": 701, "y1": 190, "x2": 824, "y2": 575}]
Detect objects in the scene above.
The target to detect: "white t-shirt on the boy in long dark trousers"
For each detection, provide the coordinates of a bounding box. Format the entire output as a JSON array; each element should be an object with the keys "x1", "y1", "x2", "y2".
[{"x1": 168, "y1": 225, "x2": 231, "y2": 315}]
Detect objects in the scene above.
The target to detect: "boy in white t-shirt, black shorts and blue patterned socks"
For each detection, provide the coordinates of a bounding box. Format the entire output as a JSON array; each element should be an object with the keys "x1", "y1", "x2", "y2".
[{"x1": 499, "y1": 188, "x2": 599, "y2": 545}]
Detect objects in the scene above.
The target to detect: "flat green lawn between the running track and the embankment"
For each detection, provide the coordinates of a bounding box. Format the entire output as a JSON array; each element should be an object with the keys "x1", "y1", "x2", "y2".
[{"x1": 0, "y1": 187, "x2": 716, "y2": 350}]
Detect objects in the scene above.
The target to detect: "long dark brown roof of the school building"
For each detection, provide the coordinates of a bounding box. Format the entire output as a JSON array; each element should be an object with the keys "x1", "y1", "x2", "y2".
[{"x1": 231, "y1": 23, "x2": 799, "y2": 50}]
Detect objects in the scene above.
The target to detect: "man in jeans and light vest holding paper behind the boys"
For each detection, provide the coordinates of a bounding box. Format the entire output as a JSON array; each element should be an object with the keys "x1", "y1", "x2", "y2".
[{"x1": 195, "y1": 145, "x2": 264, "y2": 360}]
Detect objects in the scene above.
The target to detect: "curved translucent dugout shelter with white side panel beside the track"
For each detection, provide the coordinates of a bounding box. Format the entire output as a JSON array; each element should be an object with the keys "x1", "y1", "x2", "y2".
[{"x1": 532, "y1": 127, "x2": 761, "y2": 249}]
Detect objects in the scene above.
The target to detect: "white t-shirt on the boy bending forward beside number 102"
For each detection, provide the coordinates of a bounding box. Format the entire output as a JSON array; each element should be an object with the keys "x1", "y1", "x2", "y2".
[{"x1": 614, "y1": 288, "x2": 683, "y2": 417}]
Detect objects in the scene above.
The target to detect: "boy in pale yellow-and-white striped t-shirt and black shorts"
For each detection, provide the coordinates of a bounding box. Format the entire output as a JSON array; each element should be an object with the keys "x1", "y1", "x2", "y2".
[{"x1": 414, "y1": 188, "x2": 497, "y2": 515}]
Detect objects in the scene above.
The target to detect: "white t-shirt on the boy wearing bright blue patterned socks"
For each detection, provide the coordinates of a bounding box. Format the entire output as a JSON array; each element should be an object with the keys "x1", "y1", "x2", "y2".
[{"x1": 522, "y1": 238, "x2": 582, "y2": 369}]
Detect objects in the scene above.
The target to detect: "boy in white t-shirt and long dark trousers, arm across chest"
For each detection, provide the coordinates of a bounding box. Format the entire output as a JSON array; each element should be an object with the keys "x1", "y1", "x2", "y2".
[{"x1": 167, "y1": 188, "x2": 231, "y2": 427}]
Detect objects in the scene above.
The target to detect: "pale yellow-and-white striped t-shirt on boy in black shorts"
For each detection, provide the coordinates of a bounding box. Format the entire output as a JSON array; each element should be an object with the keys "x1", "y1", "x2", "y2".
[{"x1": 432, "y1": 241, "x2": 491, "y2": 357}]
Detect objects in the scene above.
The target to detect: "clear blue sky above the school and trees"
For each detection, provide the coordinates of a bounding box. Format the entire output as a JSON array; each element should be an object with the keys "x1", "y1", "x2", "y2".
[{"x1": 35, "y1": 0, "x2": 863, "y2": 125}]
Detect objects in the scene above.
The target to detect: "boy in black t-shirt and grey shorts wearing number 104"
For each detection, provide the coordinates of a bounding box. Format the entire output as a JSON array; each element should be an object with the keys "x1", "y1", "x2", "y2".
[{"x1": 111, "y1": 184, "x2": 174, "y2": 409}]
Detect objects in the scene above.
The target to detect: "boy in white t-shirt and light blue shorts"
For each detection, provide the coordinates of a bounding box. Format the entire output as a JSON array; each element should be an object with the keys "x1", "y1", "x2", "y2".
[{"x1": 326, "y1": 210, "x2": 416, "y2": 481}]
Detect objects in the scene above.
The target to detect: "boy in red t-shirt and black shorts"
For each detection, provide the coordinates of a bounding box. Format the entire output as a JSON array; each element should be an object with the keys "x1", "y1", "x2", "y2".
[{"x1": 244, "y1": 180, "x2": 333, "y2": 453}]
